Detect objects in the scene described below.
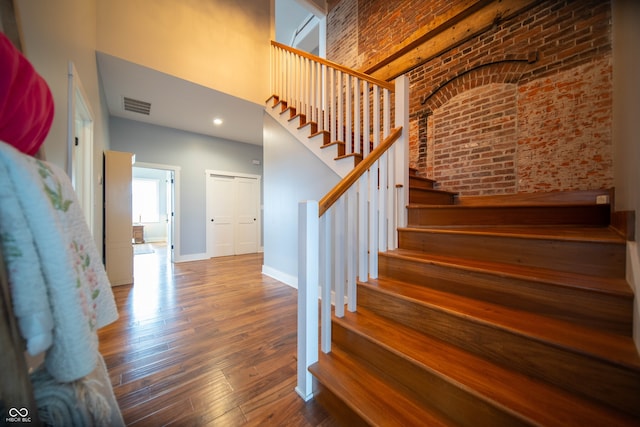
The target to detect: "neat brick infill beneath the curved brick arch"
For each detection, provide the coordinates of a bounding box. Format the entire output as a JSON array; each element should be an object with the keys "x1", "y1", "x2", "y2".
[{"x1": 427, "y1": 84, "x2": 517, "y2": 195}]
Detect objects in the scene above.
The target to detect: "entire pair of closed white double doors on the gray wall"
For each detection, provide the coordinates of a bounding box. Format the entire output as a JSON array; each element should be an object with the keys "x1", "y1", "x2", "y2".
[{"x1": 206, "y1": 170, "x2": 261, "y2": 258}]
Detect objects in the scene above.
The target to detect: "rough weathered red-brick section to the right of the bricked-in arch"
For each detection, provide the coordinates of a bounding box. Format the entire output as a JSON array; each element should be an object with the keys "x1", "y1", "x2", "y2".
[{"x1": 518, "y1": 59, "x2": 613, "y2": 192}]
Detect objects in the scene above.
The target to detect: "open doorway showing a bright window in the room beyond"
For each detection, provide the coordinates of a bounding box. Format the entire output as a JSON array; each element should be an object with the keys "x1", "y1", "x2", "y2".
[{"x1": 132, "y1": 162, "x2": 180, "y2": 262}]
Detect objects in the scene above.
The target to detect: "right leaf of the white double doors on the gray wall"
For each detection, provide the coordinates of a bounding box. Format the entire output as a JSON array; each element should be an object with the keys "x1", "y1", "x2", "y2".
[{"x1": 235, "y1": 177, "x2": 258, "y2": 255}]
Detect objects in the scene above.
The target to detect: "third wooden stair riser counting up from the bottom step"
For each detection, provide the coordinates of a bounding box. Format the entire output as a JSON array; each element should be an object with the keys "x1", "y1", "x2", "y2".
[{"x1": 358, "y1": 284, "x2": 640, "y2": 416}]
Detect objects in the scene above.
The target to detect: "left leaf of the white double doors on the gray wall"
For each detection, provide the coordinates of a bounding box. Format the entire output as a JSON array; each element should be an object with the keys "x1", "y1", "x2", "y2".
[{"x1": 207, "y1": 175, "x2": 235, "y2": 257}]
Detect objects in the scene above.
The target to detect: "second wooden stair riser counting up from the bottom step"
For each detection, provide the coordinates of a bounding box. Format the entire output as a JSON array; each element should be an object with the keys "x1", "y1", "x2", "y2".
[{"x1": 332, "y1": 321, "x2": 528, "y2": 426}]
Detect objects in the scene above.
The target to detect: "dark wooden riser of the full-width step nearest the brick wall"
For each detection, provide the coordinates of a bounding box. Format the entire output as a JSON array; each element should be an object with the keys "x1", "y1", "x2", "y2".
[{"x1": 408, "y1": 205, "x2": 610, "y2": 226}]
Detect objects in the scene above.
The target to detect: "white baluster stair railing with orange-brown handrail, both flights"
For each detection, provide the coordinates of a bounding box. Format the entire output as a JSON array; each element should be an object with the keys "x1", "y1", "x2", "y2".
[{"x1": 271, "y1": 42, "x2": 409, "y2": 400}]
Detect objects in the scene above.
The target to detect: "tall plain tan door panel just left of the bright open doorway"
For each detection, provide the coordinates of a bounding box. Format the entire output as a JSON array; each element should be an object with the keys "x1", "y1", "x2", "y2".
[{"x1": 104, "y1": 151, "x2": 133, "y2": 286}]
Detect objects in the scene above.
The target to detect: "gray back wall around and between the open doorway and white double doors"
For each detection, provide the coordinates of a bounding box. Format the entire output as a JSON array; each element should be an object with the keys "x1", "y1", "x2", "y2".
[{"x1": 109, "y1": 117, "x2": 263, "y2": 260}]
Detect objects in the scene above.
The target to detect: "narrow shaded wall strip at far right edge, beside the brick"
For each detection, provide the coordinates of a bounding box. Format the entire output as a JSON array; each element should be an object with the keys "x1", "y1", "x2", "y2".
[{"x1": 612, "y1": 0, "x2": 640, "y2": 350}]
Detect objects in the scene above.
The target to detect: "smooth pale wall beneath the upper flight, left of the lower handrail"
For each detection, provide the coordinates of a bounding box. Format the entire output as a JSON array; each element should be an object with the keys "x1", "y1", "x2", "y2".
[{"x1": 262, "y1": 114, "x2": 339, "y2": 287}]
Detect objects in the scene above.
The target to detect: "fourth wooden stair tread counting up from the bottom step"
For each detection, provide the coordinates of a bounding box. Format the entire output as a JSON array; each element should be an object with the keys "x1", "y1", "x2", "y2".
[{"x1": 381, "y1": 249, "x2": 634, "y2": 298}]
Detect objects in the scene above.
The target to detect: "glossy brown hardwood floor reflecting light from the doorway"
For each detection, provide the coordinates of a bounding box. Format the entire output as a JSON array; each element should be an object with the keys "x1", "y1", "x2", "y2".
[{"x1": 99, "y1": 245, "x2": 336, "y2": 426}]
